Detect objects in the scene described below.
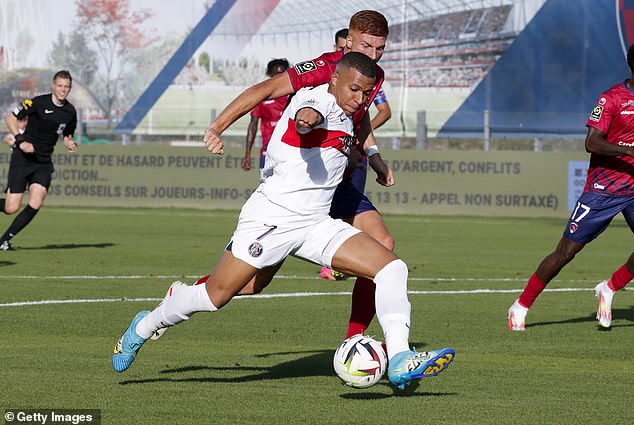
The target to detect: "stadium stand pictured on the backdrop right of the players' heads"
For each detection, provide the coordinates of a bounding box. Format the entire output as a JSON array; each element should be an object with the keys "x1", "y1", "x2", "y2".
[{"x1": 381, "y1": 5, "x2": 517, "y2": 88}]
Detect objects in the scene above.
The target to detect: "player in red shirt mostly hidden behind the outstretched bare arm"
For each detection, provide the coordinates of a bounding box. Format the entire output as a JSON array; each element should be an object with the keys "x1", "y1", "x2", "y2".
[{"x1": 242, "y1": 59, "x2": 290, "y2": 180}]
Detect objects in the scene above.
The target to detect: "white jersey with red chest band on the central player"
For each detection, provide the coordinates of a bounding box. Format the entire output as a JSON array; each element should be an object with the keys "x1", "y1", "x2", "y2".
[{"x1": 259, "y1": 84, "x2": 354, "y2": 216}]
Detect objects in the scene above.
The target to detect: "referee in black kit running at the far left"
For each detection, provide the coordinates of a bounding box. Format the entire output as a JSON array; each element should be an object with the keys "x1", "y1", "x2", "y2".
[{"x1": 0, "y1": 70, "x2": 77, "y2": 251}]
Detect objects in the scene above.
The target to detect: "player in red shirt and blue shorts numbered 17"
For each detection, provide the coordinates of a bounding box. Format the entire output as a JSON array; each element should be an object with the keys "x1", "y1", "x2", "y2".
[{"x1": 508, "y1": 45, "x2": 634, "y2": 331}]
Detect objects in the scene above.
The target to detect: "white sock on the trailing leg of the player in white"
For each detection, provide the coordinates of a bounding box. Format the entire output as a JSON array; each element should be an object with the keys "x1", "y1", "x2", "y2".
[{"x1": 136, "y1": 285, "x2": 218, "y2": 339}]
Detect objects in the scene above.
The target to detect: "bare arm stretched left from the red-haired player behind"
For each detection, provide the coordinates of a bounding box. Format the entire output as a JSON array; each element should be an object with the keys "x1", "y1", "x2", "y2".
[{"x1": 203, "y1": 72, "x2": 295, "y2": 155}]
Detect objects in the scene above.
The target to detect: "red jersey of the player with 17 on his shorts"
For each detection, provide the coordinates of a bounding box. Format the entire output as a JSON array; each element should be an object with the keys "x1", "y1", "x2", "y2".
[{"x1": 583, "y1": 80, "x2": 634, "y2": 196}]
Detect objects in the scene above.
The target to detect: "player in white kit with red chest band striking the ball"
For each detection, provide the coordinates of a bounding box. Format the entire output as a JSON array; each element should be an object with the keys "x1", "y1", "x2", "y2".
[{"x1": 112, "y1": 53, "x2": 455, "y2": 389}]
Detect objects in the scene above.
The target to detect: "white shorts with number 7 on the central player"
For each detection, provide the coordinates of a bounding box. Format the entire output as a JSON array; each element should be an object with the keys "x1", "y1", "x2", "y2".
[{"x1": 228, "y1": 191, "x2": 360, "y2": 269}]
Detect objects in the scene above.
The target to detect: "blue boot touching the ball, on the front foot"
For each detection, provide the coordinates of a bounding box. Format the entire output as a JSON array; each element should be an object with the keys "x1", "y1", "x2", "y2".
[{"x1": 387, "y1": 348, "x2": 456, "y2": 390}]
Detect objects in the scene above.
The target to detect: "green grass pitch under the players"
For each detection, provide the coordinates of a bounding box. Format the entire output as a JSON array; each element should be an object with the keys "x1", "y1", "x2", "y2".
[{"x1": 0, "y1": 207, "x2": 634, "y2": 424}]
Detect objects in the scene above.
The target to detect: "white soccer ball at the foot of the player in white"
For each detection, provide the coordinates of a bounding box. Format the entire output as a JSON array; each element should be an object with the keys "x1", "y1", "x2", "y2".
[{"x1": 332, "y1": 335, "x2": 387, "y2": 388}]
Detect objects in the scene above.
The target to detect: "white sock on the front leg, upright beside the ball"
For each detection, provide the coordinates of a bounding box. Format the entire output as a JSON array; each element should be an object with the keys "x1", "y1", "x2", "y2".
[{"x1": 374, "y1": 259, "x2": 411, "y2": 359}]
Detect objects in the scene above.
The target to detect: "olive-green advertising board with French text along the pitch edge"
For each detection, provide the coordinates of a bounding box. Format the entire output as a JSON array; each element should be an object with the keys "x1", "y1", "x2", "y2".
[{"x1": 0, "y1": 144, "x2": 588, "y2": 217}]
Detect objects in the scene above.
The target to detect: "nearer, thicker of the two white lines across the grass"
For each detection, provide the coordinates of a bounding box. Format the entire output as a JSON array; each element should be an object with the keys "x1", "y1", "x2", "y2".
[{"x1": 0, "y1": 288, "x2": 594, "y2": 307}]
